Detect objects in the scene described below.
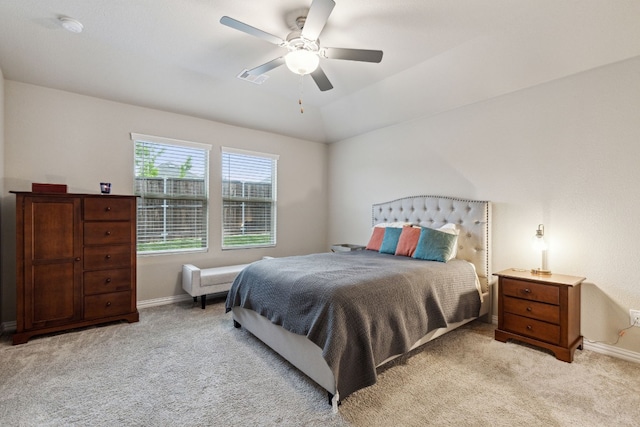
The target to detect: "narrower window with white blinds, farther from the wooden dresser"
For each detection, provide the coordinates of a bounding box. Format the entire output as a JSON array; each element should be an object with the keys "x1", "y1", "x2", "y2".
[{"x1": 222, "y1": 147, "x2": 278, "y2": 249}]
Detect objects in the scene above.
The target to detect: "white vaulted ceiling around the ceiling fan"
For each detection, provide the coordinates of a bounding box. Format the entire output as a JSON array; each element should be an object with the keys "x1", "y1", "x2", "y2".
[{"x1": 0, "y1": 0, "x2": 640, "y2": 142}]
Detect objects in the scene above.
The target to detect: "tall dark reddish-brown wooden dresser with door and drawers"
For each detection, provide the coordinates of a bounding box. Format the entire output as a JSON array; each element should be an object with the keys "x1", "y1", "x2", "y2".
[{"x1": 12, "y1": 192, "x2": 139, "y2": 344}]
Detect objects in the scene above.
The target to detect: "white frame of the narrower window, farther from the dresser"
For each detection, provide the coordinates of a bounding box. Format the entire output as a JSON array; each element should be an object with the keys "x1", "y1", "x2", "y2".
[{"x1": 220, "y1": 147, "x2": 280, "y2": 251}]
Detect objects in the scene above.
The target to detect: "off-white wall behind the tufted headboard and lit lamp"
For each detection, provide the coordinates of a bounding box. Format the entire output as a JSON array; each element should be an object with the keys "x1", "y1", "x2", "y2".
[{"x1": 329, "y1": 57, "x2": 640, "y2": 352}]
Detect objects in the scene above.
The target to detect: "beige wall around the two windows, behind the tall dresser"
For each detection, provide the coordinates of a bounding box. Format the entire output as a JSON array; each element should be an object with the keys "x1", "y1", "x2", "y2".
[{"x1": 0, "y1": 80, "x2": 328, "y2": 321}]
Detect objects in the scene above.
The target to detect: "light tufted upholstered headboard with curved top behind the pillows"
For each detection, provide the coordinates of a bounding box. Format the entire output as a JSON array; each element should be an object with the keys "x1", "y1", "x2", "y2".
[{"x1": 372, "y1": 196, "x2": 492, "y2": 290}]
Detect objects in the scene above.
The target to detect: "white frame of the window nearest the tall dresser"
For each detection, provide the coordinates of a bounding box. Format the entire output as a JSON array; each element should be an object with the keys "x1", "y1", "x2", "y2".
[{"x1": 131, "y1": 133, "x2": 211, "y2": 256}]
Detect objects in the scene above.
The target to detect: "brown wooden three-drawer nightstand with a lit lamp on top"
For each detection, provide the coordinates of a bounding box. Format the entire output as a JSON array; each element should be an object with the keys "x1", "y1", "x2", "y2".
[{"x1": 494, "y1": 269, "x2": 585, "y2": 363}]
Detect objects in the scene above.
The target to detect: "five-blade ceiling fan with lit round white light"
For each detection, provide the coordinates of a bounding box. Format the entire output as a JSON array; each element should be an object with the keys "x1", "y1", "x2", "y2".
[{"x1": 220, "y1": 0, "x2": 382, "y2": 91}]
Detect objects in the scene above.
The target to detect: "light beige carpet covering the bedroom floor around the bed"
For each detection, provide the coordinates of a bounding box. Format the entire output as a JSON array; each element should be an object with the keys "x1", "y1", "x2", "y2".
[{"x1": 0, "y1": 301, "x2": 640, "y2": 426}]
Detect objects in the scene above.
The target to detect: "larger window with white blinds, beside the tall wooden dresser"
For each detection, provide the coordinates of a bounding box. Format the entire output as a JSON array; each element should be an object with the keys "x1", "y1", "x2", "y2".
[{"x1": 131, "y1": 134, "x2": 211, "y2": 254}]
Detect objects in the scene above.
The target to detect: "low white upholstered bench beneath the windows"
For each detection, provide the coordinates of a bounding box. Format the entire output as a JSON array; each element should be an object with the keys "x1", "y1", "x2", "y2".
[{"x1": 182, "y1": 264, "x2": 249, "y2": 309}]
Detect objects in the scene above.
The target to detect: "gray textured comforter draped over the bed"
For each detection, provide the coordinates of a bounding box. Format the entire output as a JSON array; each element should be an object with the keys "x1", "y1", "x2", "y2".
[{"x1": 226, "y1": 250, "x2": 480, "y2": 399}]
